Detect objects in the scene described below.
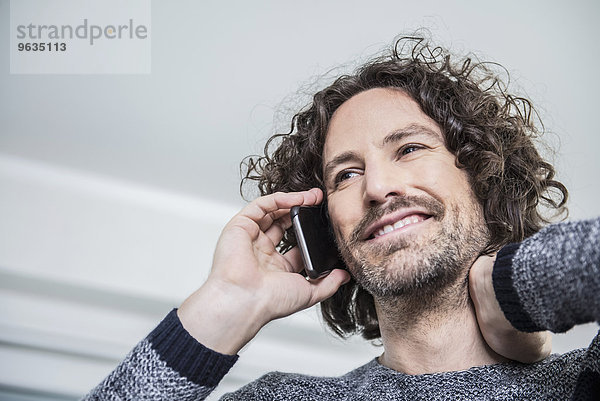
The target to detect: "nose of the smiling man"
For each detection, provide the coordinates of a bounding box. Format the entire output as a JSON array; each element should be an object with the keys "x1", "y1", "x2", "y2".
[{"x1": 363, "y1": 166, "x2": 407, "y2": 207}]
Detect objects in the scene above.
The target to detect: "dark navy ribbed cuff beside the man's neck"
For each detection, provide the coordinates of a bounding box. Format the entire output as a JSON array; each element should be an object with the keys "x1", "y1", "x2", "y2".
[{"x1": 492, "y1": 243, "x2": 544, "y2": 332}]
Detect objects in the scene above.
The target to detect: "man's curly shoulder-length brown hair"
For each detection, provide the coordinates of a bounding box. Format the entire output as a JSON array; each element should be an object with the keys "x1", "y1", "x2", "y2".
[{"x1": 242, "y1": 37, "x2": 568, "y2": 339}]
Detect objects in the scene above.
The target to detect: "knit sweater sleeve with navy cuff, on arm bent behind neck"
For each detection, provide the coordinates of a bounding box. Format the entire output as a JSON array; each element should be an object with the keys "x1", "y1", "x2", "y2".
[{"x1": 493, "y1": 218, "x2": 600, "y2": 333}]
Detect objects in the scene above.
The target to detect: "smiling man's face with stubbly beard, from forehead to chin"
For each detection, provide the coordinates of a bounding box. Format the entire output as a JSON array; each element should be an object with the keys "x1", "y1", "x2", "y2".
[{"x1": 323, "y1": 88, "x2": 488, "y2": 296}]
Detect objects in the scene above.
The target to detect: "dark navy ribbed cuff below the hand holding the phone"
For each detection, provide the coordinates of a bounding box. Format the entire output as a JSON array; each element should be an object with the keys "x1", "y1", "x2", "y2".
[{"x1": 148, "y1": 309, "x2": 238, "y2": 387}]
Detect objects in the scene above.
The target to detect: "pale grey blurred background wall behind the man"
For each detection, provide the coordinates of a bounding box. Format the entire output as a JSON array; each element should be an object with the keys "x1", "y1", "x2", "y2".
[{"x1": 0, "y1": 0, "x2": 600, "y2": 399}]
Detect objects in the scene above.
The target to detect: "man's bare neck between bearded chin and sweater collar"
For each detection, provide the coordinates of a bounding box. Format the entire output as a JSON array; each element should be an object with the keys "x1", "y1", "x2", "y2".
[{"x1": 375, "y1": 281, "x2": 506, "y2": 375}]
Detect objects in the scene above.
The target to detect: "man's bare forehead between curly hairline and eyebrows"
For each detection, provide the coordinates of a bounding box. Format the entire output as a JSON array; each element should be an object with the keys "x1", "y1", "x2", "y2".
[{"x1": 323, "y1": 88, "x2": 443, "y2": 161}]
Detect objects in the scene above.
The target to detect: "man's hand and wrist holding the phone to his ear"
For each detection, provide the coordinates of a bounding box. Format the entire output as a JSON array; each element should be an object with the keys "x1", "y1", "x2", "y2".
[{"x1": 177, "y1": 189, "x2": 350, "y2": 355}]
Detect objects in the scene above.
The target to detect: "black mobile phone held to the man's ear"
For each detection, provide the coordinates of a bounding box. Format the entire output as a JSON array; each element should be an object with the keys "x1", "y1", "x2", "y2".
[{"x1": 290, "y1": 206, "x2": 344, "y2": 278}]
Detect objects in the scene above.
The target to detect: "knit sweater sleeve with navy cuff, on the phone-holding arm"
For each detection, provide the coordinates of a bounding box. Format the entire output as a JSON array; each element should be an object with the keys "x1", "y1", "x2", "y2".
[{"x1": 83, "y1": 309, "x2": 238, "y2": 401}]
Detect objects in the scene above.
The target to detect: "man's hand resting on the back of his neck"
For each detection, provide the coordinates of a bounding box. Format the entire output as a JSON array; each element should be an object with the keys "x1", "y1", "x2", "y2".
[{"x1": 469, "y1": 255, "x2": 552, "y2": 363}]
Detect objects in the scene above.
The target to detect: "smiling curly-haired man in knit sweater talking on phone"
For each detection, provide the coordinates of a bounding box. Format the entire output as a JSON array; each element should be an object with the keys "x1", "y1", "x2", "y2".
[{"x1": 83, "y1": 38, "x2": 600, "y2": 400}]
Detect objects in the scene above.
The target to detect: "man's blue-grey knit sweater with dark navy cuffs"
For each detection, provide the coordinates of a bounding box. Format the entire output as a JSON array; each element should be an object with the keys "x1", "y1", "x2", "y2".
[{"x1": 84, "y1": 219, "x2": 600, "y2": 401}]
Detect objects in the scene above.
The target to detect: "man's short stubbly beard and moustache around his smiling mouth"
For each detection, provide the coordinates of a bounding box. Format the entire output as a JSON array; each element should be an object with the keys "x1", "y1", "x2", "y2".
[{"x1": 336, "y1": 196, "x2": 489, "y2": 300}]
